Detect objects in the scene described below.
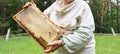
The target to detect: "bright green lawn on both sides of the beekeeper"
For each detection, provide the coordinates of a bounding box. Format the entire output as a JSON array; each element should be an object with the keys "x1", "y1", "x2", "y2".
[{"x1": 0, "y1": 34, "x2": 120, "y2": 54}]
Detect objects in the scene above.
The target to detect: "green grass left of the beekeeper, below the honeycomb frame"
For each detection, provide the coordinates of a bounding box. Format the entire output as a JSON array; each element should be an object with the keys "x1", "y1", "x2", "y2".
[{"x1": 0, "y1": 36, "x2": 54, "y2": 54}]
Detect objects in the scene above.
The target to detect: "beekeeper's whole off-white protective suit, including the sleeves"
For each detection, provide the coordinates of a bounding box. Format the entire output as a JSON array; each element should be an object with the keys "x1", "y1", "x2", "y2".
[{"x1": 44, "y1": 0, "x2": 95, "y2": 54}]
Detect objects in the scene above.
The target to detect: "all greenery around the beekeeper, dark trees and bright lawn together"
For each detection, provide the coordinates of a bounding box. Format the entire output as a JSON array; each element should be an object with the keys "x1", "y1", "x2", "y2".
[{"x1": 0, "y1": 0, "x2": 120, "y2": 54}]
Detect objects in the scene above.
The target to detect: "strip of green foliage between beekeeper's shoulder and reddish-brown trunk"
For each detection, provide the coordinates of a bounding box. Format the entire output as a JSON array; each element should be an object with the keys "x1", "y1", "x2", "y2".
[{"x1": 90, "y1": 0, "x2": 101, "y2": 32}]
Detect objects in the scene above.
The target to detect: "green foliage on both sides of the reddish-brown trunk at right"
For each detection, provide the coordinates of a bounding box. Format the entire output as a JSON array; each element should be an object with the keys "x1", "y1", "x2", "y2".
[{"x1": 90, "y1": 0, "x2": 117, "y2": 33}]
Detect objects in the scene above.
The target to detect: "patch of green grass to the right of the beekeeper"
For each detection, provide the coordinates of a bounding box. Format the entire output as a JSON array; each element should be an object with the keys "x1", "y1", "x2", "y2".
[{"x1": 95, "y1": 34, "x2": 120, "y2": 54}]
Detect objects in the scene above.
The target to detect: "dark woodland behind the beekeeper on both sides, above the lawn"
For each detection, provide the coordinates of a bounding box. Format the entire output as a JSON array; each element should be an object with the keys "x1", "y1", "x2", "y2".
[{"x1": 0, "y1": 0, "x2": 120, "y2": 35}]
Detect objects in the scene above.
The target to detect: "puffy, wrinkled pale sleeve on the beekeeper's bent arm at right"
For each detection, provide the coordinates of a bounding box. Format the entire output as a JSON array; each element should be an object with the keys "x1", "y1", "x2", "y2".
[{"x1": 61, "y1": 3, "x2": 94, "y2": 53}]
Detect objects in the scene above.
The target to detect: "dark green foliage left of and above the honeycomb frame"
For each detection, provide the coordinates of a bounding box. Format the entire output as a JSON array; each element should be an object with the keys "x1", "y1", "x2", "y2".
[{"x1": 0, "y1": 0, "x2": 53, "y2": 33}]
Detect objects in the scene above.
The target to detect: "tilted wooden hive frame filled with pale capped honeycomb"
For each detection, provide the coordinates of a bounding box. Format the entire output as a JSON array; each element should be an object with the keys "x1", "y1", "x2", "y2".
[{"x1": 13, "y1": 4, "x2": 62, "y2": 49}]
